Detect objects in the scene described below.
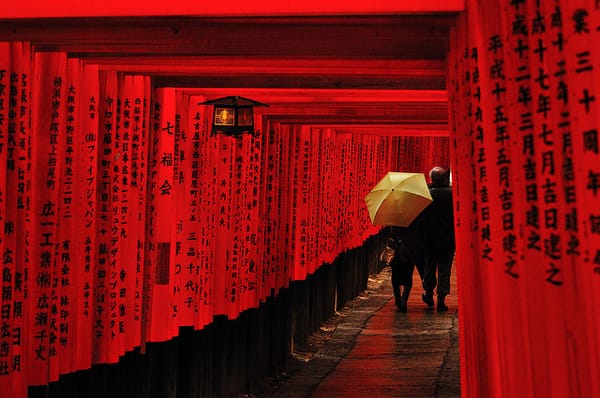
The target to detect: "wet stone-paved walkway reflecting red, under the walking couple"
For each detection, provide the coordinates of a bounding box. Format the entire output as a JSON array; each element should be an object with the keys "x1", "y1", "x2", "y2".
[{"x1": 248, "y1": 268, "x2": 460, "y2": 398}]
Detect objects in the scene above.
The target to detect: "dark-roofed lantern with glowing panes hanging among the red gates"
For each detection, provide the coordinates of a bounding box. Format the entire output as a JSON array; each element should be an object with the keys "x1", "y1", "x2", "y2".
[{"x1": 198, "y1": 96, "x2": 269, "y2": 136}]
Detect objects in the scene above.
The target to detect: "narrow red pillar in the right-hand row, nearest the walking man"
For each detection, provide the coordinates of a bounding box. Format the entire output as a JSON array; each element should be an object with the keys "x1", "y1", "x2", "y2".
[{"x1": 448, "y1": 15, "x2": 485, "y2": 397}]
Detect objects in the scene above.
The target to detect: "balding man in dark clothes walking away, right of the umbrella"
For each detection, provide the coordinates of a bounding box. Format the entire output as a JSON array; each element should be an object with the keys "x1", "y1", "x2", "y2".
[{"x1": 421, "y1": 166, "x2": 456, "y2": 312}]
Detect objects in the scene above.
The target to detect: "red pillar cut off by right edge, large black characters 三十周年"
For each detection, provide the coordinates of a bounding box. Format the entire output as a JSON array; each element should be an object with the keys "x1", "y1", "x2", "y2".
[{"x1": 555, "y1": 0, "x2": 600, "y2": 396}]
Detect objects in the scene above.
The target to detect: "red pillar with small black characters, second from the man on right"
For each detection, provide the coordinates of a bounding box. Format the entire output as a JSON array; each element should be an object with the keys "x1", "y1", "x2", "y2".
[{"x1": 470, "y1": 2, "x2": 514, "y2": 395}]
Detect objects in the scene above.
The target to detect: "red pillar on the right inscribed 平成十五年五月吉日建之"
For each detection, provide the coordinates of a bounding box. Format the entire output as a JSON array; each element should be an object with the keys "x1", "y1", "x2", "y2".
[{"x1": 486, "y1": 3, "x2": 530, "y2": 395}]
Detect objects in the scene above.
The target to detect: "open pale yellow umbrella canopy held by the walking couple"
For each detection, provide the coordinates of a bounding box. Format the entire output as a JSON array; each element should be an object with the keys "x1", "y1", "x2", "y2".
[{"x1": 365, "y1": 171, "x2": 433, "y2": 227}]
